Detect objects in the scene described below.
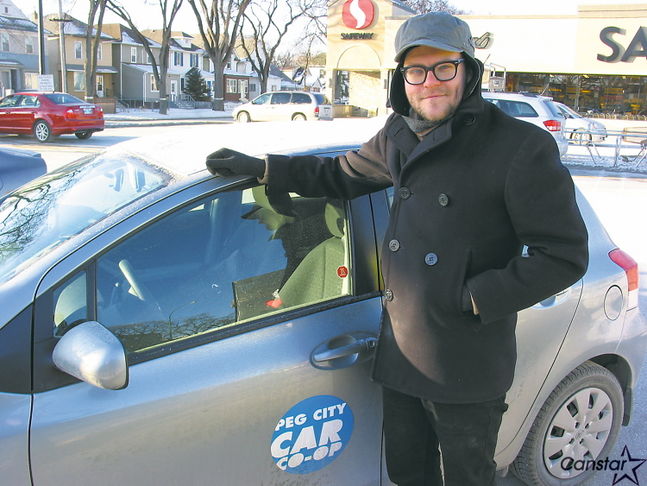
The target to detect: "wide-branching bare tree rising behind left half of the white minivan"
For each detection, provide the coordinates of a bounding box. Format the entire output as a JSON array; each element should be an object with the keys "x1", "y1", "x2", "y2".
[{"x1": 241, "y1": 0, "x2": 315, "y2": 93}]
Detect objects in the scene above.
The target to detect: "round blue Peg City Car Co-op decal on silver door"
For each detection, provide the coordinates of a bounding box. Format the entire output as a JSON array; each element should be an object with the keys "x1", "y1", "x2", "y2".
[{"x1": 270, "y1": 395, "x2": 354, "y2": 474}]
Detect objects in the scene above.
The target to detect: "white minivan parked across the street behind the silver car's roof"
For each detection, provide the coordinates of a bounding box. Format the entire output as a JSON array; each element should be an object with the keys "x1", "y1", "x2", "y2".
[{"x1": 232, "y1": 91, "x2": 333, "y2": 123}]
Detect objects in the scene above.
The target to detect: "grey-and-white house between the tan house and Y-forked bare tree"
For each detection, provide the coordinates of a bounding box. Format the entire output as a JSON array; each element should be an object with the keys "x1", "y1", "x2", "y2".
[{"x1": 102, "y1": 24, "x2": 161, "y2": 106}]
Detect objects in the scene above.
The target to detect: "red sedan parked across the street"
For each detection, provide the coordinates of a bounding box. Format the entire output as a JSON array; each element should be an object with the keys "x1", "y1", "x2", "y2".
[{"x1": 0, "y1": 92, "x2": 104, "y2": 142}]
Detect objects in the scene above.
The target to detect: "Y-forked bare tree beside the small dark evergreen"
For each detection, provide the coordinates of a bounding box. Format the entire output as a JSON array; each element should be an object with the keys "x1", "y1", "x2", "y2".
[{"x1": 107, "y1": 0, "x2": 184, "y2": 115}]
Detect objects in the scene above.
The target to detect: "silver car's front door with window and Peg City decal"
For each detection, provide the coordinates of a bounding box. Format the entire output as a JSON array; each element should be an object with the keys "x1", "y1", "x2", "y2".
[{"x1": 30, "y1": 181, "x2": 382, "y2": 486}]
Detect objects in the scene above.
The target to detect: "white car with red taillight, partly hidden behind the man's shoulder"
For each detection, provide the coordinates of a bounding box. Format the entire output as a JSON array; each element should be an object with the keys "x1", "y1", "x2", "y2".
[{"x1": 483, "y1": 91, "x2": 568, "y2": 156}]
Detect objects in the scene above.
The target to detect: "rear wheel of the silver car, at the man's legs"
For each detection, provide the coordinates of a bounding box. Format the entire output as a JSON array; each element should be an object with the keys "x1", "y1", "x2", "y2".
[{"x1": 511, "y1": 361, "x2": 624, "y2": 486}]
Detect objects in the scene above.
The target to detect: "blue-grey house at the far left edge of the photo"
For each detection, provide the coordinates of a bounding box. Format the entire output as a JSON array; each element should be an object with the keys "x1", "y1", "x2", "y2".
[{"x1": 0, "y1": 0, "x2": 39, "y2": 96}]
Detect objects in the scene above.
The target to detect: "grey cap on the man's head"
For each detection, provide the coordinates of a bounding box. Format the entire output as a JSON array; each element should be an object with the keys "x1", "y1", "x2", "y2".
[{"x1": 395, "y1": 12, "x2": 474, "y2": 63}]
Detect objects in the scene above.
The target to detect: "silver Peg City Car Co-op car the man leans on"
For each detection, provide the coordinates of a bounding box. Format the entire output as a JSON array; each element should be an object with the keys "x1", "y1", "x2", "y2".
[{"x1": 0, "y1": 130, "x2": 647, "y2": 486}]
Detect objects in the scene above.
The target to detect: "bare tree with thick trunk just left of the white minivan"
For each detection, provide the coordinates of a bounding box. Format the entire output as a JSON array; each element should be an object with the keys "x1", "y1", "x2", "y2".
[{"x1": 187, "y1": 0, "x2": 250, "y2": 111}]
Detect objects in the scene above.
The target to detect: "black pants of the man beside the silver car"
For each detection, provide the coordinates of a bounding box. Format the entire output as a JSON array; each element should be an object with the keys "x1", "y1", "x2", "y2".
[{"x1": 383, "y1": 388, "x2": 508, "y2": 486}]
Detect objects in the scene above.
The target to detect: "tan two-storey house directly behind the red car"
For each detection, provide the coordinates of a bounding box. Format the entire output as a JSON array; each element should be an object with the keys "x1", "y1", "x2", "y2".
[{"x1": 44, "y1": 14, "x2": 119, "y2": 99}]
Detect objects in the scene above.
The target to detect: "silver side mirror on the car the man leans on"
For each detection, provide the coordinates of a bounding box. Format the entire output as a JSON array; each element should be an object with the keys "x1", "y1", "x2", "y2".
[{"x1": 53, "y1": 321, "x2": 128, "y2": 390}]
